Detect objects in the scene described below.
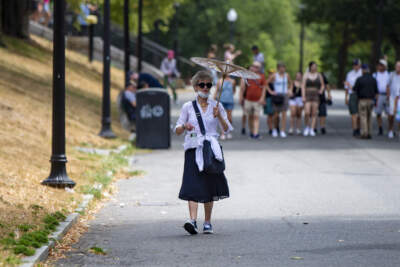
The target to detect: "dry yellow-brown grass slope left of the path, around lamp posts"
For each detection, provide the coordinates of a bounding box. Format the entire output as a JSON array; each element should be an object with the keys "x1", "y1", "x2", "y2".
[{"x1": 0, "y1": 36, "x2": 127, "y2": 265}]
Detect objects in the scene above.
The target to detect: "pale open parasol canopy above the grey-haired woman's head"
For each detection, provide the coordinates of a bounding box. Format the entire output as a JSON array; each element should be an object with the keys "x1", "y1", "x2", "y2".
[{"x1": 190, "y1": 57, "x2": 260, "y2": 79}]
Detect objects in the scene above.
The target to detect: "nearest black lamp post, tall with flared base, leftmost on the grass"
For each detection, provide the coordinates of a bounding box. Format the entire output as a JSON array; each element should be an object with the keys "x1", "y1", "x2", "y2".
[{"x1": 42, "y1": 0, "x2": 75, "y2": 188}]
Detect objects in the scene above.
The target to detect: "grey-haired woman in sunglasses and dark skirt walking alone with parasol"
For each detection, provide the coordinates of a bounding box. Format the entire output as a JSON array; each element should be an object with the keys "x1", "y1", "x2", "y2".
[{"x1": 175, "y1": 71, "x2": 233, "y2": 235}]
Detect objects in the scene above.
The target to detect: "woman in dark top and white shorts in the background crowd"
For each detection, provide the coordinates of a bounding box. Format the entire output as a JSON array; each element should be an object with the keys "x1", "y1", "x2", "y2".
[{"x1": 289, "y1": 72, "x2": 304, "y2": 135}]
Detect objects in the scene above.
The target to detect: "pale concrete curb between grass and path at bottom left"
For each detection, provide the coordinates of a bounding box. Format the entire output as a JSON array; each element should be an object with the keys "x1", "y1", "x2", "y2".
[{"x1": 20, "y1": 195, "x2": 93, "y2": 267}]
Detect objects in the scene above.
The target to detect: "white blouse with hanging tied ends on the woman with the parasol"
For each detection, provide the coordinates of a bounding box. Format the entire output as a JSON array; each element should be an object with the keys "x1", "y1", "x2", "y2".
[{"x1": 174, "y1": 99, "x2": 233, "y2": 171}]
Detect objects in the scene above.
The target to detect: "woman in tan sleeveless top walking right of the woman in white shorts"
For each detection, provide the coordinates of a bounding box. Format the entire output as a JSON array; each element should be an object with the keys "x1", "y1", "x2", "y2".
[{"x1": 301, "y1": 61, "x2": 325, "y2": 136}]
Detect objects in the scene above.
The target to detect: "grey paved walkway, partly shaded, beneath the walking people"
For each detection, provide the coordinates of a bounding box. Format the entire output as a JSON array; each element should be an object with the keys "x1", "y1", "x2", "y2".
[{"x1": 57, "y1": 90, "x2": 400, "y2": 267}]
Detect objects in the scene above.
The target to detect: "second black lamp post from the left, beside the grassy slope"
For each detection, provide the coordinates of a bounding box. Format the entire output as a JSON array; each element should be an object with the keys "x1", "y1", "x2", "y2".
[{"x1": 99, "y1": 0, "x2": 116, "y2": 138}]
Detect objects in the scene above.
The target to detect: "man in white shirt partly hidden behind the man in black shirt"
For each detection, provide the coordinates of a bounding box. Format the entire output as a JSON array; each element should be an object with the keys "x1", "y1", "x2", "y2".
[{"x1": 344, "y1": 59, "x2": 362, "y2": 136}]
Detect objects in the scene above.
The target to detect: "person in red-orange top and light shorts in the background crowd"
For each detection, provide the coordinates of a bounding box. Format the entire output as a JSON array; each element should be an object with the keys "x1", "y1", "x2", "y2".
[{"x1": 239, "y1": 61, "x2": 267, "y2": 139}]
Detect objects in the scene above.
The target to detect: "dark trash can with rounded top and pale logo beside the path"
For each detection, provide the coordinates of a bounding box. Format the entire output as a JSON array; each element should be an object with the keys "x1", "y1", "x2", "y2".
[{"x1": 136, "y1": 88, "x2": 171, "y2": 149}]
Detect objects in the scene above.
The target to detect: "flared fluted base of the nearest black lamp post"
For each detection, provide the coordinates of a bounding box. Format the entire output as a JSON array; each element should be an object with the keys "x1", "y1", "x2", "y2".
[{"x1": 42, "y1": 158, "x2": 75, "y2": 188}]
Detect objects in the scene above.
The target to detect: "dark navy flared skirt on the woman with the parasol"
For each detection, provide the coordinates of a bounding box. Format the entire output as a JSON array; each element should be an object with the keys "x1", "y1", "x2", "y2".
[{"x1": 179, "y1": 149, "x2": 229, "y2": 203}]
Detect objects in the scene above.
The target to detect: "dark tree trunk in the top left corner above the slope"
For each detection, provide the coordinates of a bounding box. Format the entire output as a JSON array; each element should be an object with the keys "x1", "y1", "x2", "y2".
[{"x1": 0, "y1": 0, "x2": 30, "y2": 38}]
